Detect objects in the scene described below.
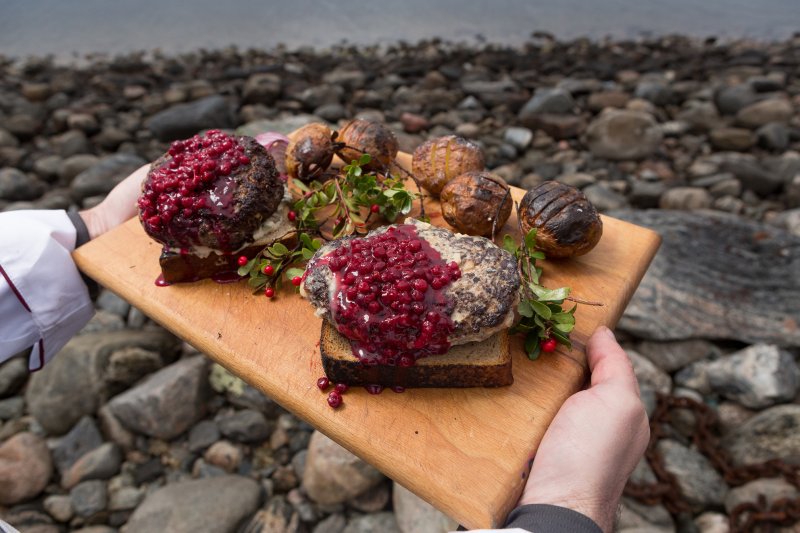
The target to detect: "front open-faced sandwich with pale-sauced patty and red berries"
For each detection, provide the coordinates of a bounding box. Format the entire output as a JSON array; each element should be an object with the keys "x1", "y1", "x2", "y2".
[{"x1": 301, "y1": 219, "x2": 520, "y2": 388}]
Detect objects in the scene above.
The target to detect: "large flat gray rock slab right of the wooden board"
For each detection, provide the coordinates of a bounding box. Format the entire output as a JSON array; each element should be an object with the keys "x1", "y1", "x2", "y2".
[{"x1": 609, "y1": 210, "x2": 800, "y2": 346}]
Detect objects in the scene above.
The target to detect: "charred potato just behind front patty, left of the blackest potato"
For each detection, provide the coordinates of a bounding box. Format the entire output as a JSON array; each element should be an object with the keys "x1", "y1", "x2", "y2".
[{"x1": 439, "y1": 171, "x2": 513, "y2": 236}]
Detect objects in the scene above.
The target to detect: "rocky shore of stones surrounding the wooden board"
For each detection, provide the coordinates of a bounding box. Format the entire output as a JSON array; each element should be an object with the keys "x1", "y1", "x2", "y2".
[{"x1": 0, "y1": 37, "x2": 800, "y2": 533}]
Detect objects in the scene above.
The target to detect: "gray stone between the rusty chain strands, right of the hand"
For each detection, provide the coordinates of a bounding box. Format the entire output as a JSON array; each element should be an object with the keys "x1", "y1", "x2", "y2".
[{"x1": 657, "y1": 439, "x2": 728, "y2": 508}]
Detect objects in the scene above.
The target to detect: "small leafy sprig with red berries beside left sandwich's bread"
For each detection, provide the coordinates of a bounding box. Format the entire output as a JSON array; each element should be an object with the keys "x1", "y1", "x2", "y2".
[{"x1": 239, "y1": 232, "x2": 322, "y2": 298}]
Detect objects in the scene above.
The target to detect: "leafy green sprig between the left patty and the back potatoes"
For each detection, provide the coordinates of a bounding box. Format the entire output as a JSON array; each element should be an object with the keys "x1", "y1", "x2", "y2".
[{"x1": 292, "y1": 154, "x2": 418, "y2": 238}]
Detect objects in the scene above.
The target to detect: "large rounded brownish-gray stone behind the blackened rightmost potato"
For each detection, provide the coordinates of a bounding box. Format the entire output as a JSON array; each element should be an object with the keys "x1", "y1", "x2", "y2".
[{"x1": 586, "y1": 110, "x2": 662, "y2": 160}]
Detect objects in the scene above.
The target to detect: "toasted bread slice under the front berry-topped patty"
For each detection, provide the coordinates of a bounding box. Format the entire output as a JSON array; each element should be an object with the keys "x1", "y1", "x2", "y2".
[{"x1": 320, "y1": 320, "x2": 514, "y2": 388}]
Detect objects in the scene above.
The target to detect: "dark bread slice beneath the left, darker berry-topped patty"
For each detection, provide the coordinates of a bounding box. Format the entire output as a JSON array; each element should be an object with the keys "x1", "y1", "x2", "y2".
[{"x1": 158, "y1": 202, "x2": 297, "y2": 283}]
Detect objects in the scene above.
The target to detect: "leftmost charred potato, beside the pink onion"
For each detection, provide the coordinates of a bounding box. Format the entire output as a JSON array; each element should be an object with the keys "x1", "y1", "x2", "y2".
[{"x1": 286, "y1": 123, "x2": 333, "y2": 182}]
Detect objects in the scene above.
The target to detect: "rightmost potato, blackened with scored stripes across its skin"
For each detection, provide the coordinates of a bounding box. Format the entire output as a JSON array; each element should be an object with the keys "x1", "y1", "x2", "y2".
[{"x1": 519, "y1": 181, "x2": 603, "y2": 258}]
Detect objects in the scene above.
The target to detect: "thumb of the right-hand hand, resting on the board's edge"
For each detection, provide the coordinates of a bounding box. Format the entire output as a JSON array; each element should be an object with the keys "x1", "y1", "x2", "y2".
[{"x1": 586, "y1": 326, "x2": 639, "y2": 395}]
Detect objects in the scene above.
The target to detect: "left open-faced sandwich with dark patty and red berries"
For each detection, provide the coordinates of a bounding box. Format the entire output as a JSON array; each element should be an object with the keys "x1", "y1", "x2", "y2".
[{"x1": 138, "y1": 130, "x2": 295, "y2": 284}]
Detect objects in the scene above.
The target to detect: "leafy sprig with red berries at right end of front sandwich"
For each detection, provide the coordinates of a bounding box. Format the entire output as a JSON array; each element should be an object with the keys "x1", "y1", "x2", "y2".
[{"x1": 503, "y1": 228, "x2": 578, "y2": 360}]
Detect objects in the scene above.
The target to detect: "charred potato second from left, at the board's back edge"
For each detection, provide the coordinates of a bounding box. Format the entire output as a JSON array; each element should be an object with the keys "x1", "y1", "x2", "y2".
[{"x1": 336, "y1": 119, "x2": 399, "y2": 171}]
